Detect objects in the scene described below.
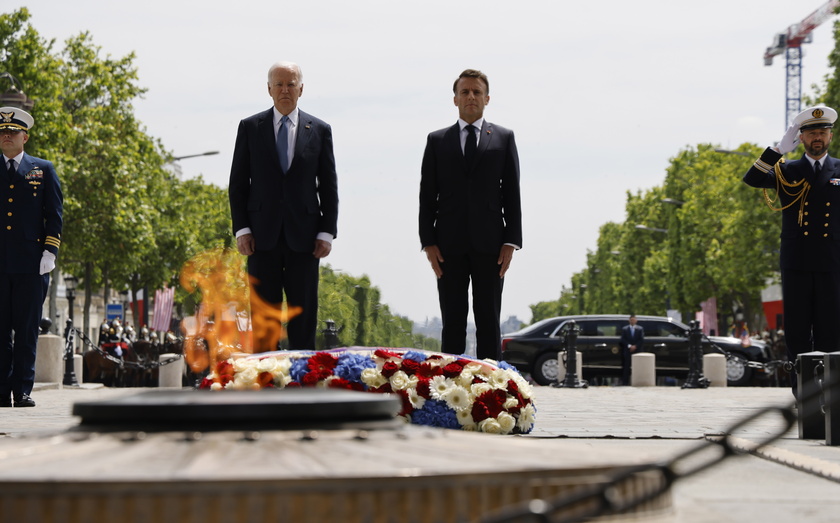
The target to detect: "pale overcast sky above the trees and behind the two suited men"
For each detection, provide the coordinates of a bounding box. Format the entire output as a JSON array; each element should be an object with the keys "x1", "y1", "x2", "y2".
[{"x1": 13, "y1": 0, "x2": 834, "y2": 322}]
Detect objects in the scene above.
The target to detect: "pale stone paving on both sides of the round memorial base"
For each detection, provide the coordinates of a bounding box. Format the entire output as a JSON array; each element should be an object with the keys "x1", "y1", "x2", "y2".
[{"x1": 0, "y1": 384, "x2": 840, "y2": 523}]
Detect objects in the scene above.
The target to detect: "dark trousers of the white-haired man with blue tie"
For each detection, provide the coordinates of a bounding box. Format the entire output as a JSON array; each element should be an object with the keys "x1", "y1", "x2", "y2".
[{"x1": 248, "y1": 242, "x2": 320, "y2": 351}]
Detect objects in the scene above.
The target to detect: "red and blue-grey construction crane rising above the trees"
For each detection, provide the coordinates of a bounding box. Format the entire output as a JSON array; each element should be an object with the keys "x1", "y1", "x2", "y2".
[{"x1": 764, "y1": 0, "x2": 840, "y2": 129}]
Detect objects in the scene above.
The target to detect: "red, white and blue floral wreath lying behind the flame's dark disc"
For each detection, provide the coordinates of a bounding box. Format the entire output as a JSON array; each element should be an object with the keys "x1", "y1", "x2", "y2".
[{"x1": 199, "y1": 347, "x2": 536, "y2": 434}]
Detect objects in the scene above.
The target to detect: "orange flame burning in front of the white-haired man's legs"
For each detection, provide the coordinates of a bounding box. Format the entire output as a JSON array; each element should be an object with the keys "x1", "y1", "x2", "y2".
[{"x1": 181, "y1": 249, "x2": 301, "y2": 378}]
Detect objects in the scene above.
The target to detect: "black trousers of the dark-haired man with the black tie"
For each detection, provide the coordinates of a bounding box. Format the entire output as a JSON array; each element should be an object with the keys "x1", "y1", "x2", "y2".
[{"x1": 438, "y1": 252, "x2": 504, "y2": 360}]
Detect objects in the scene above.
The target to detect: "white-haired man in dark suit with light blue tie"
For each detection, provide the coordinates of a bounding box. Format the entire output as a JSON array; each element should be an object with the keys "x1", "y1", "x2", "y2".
[{"x1": 229, "y1": 62, "x2": 338, "y2": 351}]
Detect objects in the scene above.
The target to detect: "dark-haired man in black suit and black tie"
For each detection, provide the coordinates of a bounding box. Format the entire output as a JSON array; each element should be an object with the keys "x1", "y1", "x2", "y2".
[{"x1": 420, "y1": 69, "x2": 522, "y2": 360}]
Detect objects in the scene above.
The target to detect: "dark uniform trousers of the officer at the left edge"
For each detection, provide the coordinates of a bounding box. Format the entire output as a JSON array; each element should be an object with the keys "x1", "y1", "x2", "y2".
[{"x1": 0, "y1": 273, "x2": 44, "y2": 398}]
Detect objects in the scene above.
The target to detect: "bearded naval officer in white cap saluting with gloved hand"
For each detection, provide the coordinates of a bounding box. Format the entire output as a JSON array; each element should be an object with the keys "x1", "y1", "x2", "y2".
[{"x1": 744, "y1": 106, "x2": 840, "y2": 393}]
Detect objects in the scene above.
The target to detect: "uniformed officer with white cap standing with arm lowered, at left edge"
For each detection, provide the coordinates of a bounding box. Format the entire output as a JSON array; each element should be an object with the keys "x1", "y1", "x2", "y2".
[{"x1": 0, "y1": 107, "x2": 63, "y2": 407}]
